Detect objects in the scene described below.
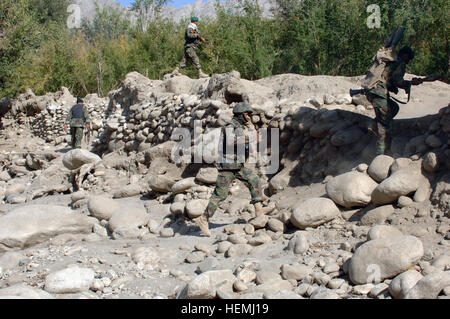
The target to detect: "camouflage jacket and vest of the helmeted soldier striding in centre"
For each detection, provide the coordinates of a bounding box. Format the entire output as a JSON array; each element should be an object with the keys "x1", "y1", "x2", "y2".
[{"x1": 217, "y1": 119, "x2": 256, "y2": 170}]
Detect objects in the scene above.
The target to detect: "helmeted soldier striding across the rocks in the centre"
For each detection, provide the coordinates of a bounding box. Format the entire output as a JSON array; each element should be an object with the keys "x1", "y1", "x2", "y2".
[{"x1": 194, "y1": 102, "x2": 275, "y2": 237}]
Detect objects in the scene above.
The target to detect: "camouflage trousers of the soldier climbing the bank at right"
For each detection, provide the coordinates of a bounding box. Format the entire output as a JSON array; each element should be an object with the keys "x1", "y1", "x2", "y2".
[{"x1": 367, "y1": 93, "x2": 399, "y2": 155}]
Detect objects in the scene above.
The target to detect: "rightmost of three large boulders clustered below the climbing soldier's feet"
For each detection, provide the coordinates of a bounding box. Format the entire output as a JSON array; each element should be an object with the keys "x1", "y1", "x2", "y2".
[{"x1": 372, "y1": 169, "x2": 425, "y2": 205}]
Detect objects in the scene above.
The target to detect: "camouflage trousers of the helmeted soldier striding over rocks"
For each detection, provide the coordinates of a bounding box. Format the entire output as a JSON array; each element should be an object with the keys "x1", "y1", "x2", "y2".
[{"x1": 206, "y1": 167, "x2": 262, "y2": 218}]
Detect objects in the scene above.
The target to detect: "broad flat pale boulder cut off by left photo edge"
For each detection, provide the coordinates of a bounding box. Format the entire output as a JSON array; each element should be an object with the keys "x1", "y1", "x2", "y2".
[{"x1": 0, "y1": 205, "x2": 95, "y2": 251}]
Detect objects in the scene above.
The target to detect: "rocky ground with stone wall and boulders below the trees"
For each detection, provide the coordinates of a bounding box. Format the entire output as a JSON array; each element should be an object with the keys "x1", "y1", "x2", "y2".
[{"x1": 0, "y1": 72, "x2": 450, "y2": 299}]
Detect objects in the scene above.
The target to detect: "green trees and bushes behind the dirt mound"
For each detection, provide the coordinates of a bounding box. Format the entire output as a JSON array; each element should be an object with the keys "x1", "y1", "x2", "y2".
[{"x1": 0, "y1": 0, "x2": 450, "y2": 98}]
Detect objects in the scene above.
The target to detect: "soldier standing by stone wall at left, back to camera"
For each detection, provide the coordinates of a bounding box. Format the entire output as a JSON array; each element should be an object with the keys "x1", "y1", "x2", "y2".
[{"x1": 64, "y1": 98, "x2": 91, "y2": 148}]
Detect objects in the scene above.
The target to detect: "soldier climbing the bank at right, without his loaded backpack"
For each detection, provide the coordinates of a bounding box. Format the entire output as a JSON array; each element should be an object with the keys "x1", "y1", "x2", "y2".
[{"x1": 366, "y1": 46, "x2": 420, "y2": 155}]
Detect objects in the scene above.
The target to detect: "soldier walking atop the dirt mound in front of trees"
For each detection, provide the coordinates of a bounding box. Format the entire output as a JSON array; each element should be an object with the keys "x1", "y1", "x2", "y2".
[{"x1": 172, "y1": 17, "x2": 208, "y2": 78}]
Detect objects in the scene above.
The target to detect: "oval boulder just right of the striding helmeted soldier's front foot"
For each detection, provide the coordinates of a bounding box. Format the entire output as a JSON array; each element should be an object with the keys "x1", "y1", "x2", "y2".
[{"x1": 290, "y1": 198, "x2": 340, "y2": 229}]
